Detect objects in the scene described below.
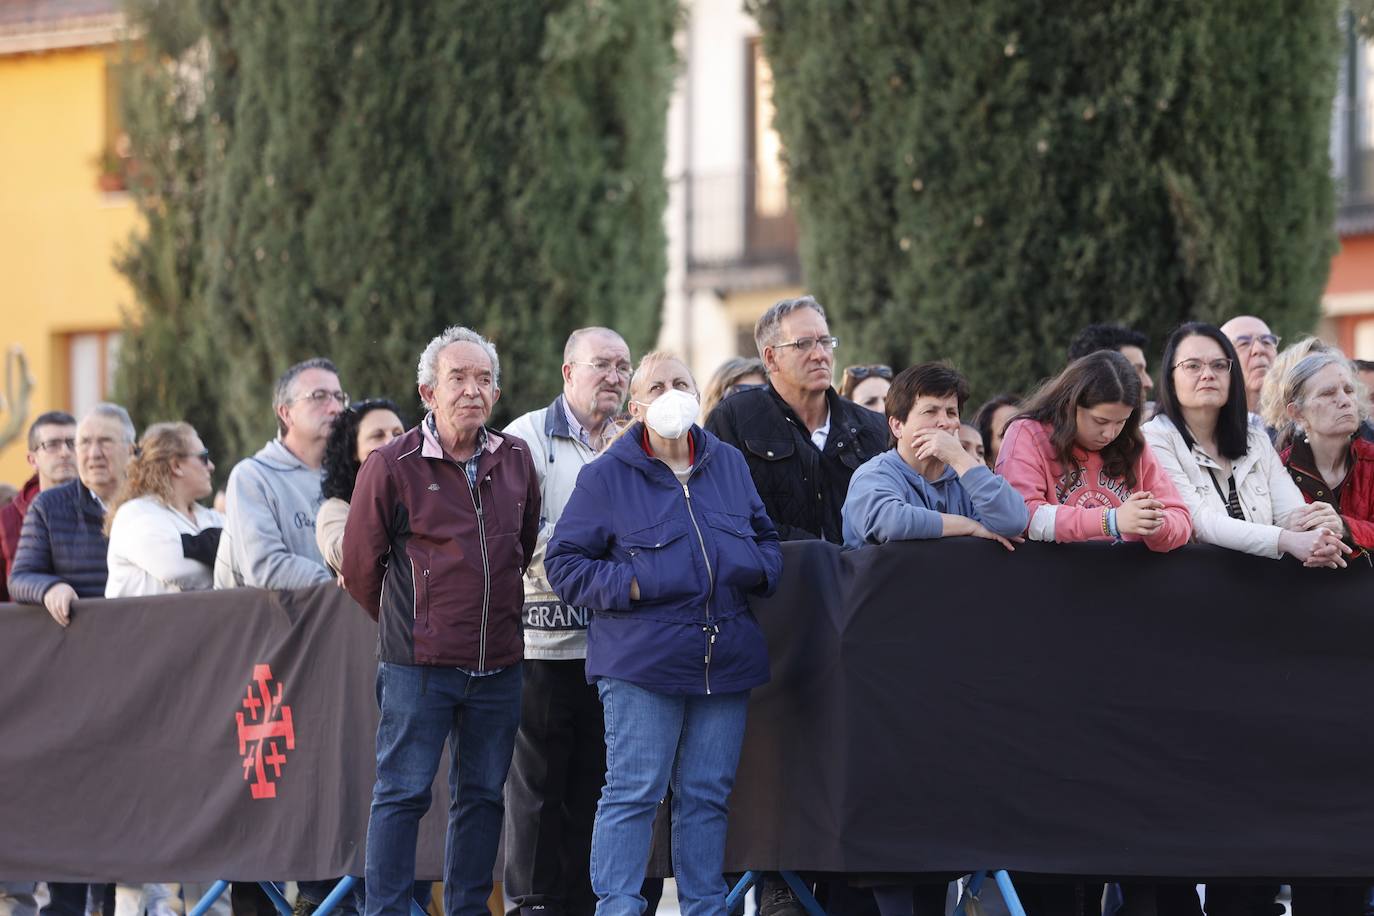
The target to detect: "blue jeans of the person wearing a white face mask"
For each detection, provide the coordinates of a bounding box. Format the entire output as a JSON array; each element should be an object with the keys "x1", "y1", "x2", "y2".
[{"x1": 592, "y1": 677, "x2": 749, "y2": 916}]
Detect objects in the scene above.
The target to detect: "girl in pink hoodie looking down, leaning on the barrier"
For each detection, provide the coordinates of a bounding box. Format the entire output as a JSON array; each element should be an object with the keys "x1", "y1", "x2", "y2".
[{"x1": 998, "y1": 350, "x2": 1193, "y2": 551}]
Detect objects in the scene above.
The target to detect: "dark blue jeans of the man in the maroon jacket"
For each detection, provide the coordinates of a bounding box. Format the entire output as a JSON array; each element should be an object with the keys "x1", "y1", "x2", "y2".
[{"x1": 365, "y1": 662, "x2": 521, "y2": 916}]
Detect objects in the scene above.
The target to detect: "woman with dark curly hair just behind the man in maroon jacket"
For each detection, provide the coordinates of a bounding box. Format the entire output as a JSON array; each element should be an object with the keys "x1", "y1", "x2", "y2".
[{"x1": 315, "y1": 398, "x2": 405, "y2": 573}]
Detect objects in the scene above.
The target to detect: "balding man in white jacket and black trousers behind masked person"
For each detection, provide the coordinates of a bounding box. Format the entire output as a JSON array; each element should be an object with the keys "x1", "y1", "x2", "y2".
[{"x1": 504, "y1": 327, "x2": 631, "y2": 916}]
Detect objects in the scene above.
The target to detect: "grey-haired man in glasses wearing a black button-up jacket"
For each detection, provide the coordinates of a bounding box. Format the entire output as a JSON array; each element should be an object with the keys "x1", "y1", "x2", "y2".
[{"x1": 706, "y1": 295, "x2": 888, "y2": 544}]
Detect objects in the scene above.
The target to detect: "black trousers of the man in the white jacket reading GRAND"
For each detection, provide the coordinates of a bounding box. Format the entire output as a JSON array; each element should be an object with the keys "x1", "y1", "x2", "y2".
[{"x1": 504, "y1": 659, "x2": 606, "y2": 916}]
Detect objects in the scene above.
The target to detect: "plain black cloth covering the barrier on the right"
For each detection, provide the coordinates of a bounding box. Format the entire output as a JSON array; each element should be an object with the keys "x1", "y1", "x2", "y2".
[{"x1": 725, "y1": 538, "x2": 1374, "y2": 878}]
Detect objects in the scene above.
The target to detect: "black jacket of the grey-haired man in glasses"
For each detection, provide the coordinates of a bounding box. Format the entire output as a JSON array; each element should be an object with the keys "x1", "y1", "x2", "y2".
[{"x1": 706, "y1": 385, "x2": 888, "y2": 544}]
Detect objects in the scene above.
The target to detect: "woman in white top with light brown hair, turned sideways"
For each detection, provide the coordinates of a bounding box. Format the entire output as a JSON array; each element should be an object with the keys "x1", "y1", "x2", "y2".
[{"x1": 104, "y1": 423, "x2": 229, "y2": 916}]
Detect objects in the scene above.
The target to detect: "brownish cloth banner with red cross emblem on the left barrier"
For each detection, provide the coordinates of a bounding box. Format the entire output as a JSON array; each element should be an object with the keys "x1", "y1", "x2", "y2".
[{"x1": 0, "y1": 585, "x2": 448, "y2": 883}]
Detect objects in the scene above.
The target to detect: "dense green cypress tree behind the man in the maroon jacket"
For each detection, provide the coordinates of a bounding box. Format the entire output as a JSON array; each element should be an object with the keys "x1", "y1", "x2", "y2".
[{"x1": 119, "y1": 0, "x2": 679, "y2": 469}]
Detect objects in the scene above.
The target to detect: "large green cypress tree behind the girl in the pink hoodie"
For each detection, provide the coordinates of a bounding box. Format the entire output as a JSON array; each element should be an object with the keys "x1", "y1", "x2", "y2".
[{"x1": 749, "y1": 0, "x2": 1340, "y2": 397}]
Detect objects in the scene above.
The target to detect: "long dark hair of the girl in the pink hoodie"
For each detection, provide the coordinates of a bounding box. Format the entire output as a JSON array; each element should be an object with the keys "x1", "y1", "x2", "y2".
[{"x1": 1015, "y1": 350, "x2": 1145, "y2": 489}]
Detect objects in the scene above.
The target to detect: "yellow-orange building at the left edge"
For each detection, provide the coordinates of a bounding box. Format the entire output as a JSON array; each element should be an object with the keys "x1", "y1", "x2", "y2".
[{"x1": 0, "y1": 0, "x2": 137, "y2": 483}]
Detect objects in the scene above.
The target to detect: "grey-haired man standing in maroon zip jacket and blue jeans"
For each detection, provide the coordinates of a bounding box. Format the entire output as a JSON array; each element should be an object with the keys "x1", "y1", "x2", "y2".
[{"x1": 339, "y1": 327, "x2": 540, "y2": 916}]
